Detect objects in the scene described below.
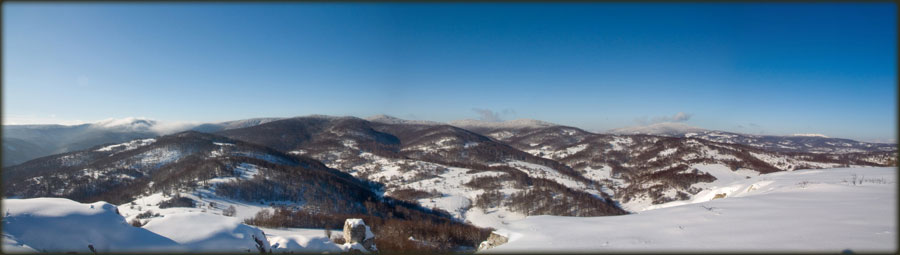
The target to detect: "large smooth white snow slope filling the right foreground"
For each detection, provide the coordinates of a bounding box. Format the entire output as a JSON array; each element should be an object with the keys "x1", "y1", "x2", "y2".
[{"x1": 482, "y1": 167, "x2": 897, "y2": 253}]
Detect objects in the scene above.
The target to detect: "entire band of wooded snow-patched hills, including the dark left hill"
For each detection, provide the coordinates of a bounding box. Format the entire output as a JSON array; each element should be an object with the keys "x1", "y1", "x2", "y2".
[{"x1": 4, "y1": 115, "x2": 896, "y2": 232}]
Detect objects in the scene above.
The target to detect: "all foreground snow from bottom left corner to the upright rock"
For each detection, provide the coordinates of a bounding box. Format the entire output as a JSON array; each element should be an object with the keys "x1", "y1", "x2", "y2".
[{"x1": 2, "y1": 194, "x2": 351, "y2": 253}]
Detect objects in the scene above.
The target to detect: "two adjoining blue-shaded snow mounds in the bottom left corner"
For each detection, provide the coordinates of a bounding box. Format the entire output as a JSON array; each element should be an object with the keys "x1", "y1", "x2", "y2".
[{"x1": 3, "y1": 198, "x2": 278, "y2": 253}]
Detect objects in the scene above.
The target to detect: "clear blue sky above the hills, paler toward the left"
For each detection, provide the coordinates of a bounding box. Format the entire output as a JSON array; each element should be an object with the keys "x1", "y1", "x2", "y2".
[{"x1": 3, "y1": 3, "x2": 897, "y2": 140}]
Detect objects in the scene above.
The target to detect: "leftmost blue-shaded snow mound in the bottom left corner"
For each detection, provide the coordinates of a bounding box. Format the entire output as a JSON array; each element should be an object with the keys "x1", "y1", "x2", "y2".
[{"x1": 3, "y1": 198, "x2": 186, "y2": 253}]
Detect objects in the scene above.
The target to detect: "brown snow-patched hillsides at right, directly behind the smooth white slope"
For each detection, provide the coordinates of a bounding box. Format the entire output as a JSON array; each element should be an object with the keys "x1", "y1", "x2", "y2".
[{"x1": 472, "y1": 126, "x2": 897, "y2": 211}]
